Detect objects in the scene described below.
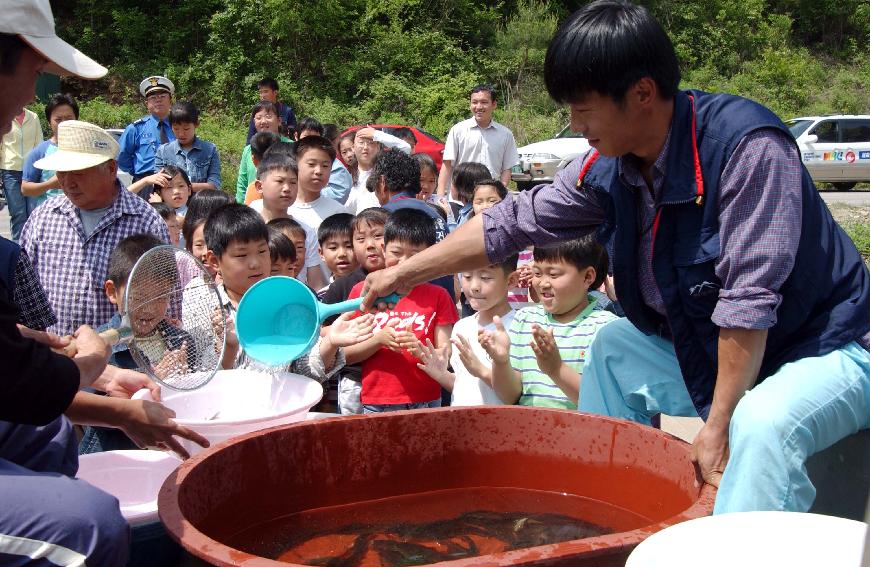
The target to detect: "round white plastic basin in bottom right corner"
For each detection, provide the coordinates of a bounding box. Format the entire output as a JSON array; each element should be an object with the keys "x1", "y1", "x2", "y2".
[{"x1": 625, "y1": 512, "x2": 867, "y2": 567}]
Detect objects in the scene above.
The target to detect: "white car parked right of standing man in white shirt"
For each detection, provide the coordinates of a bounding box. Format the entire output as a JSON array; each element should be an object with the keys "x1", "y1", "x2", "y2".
[{"x1": 511, "y1": 126, "x2": 589, "y2": 191}]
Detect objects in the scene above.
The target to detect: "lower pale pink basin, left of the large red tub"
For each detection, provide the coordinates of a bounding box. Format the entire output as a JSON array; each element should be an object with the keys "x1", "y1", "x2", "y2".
[{"x1": 76, "y1": 451, "x2": 181, "y2": 526}]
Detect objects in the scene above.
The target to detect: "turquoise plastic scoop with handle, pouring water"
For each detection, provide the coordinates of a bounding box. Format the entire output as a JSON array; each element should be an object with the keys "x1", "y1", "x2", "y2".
[{"x1": 236, "y1": 276, "x2": 400, "y2": 366}]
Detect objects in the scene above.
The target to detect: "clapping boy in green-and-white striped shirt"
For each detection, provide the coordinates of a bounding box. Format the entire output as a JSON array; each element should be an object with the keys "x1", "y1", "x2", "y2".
[{"x1": 478, "y1": 237, "x2": 617, "y2": 409}]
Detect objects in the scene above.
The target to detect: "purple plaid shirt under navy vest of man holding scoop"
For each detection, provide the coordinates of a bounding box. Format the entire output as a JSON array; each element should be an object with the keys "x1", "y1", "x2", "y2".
[{"x1": 483, "y1": 129, "x2": 801, "y2": 329}]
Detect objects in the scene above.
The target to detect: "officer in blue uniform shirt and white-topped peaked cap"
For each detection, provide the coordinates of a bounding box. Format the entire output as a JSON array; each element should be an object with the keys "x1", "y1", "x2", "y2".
[{"x1": 118, "y1": 76, "x2": 175, "y2": 200}]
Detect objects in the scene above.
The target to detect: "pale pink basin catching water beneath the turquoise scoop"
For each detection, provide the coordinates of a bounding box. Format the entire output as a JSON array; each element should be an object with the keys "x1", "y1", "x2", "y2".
[{"x1": 133, "y1": 370, "x2": 323, "y2": 455}]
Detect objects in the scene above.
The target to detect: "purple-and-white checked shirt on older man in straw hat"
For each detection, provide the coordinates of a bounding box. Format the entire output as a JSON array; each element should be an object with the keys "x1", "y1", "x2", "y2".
[{"x1": 21, "y1": 183, "x2": 169, "y2": 335}]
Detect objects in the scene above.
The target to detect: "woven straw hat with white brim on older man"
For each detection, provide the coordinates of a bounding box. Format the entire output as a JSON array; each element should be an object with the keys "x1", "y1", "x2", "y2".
[{"x1": 33, "y1": 120, "x2": 121, "y2": 171}]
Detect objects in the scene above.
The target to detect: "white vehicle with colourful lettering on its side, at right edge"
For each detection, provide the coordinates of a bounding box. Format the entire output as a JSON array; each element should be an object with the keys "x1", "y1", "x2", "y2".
[{"x1": 785, "y1": 114, "x2": 870, "y2": 191}]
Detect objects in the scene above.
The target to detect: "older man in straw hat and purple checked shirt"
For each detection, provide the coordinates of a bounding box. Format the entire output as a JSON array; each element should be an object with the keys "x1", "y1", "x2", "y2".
[{"x1": 21, "y1": 120, "x2": 169, "y2": 335}]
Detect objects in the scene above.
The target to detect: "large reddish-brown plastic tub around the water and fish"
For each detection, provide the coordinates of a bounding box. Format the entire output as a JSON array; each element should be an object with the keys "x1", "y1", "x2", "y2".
[{"x1": 158, "y1": 406, "x2": 715, "y2": 567}]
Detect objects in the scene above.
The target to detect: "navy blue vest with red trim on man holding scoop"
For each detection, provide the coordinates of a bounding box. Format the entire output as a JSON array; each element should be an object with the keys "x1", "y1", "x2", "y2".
[{"x1": 581, "y1": 91, "x2": 870, "y2": 418}]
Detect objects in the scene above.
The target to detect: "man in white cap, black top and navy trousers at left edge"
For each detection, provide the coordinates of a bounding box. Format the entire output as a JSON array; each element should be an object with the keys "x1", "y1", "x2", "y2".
[{"x1": 0, "y1": 0, "x2": 158, "y2": 566}]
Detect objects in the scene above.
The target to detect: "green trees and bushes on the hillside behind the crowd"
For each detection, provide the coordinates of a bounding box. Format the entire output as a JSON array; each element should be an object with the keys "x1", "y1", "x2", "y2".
[{"x1": 53, "y1": 0, "x2": 870, "y2": 191}]
